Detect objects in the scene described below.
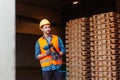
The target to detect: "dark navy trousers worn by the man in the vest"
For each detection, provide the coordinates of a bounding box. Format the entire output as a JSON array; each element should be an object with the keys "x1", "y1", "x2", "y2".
[{"x1": 42, "y1": 70, "x2": 64, "y2": 80}]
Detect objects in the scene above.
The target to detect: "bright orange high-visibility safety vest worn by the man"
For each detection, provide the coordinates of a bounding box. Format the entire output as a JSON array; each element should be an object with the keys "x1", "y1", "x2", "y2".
[{"x1": 38, "y1": 35, "x2": 62, "y2": 67}]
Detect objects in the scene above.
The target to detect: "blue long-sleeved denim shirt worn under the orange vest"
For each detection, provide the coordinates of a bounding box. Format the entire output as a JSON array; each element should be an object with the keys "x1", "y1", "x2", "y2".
[{"x1": 35, "y1": 37, "x2": 65, "y2": 71}]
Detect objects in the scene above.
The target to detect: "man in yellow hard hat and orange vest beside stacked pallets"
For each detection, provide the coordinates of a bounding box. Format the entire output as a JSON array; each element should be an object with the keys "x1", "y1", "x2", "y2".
[{"x1": 35, "y1": 19, "x2": 65, "y2": 80}]
